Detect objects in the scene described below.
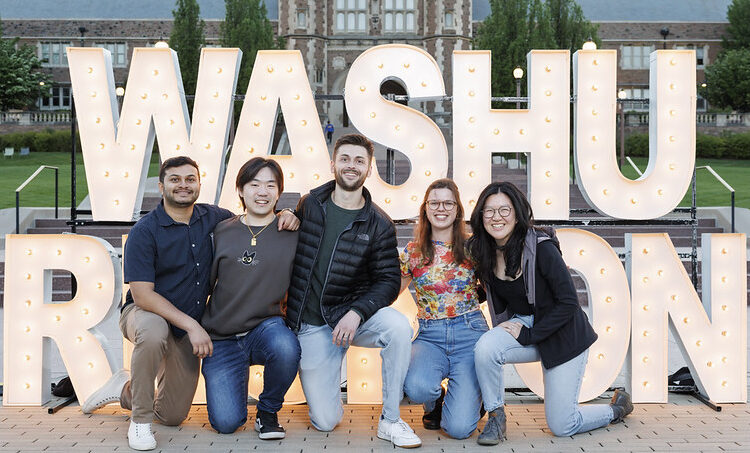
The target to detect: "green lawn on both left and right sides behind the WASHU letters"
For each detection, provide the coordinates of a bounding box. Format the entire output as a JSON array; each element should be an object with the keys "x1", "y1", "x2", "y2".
[{"x1": 0, "y1": 152, "x2": 750, "y2": 209}]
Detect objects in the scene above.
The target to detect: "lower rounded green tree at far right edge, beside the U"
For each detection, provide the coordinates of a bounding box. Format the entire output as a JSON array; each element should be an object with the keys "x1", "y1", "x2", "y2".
[{"x1": 700, "y1": 48, "x2": 750, "y2": 112}]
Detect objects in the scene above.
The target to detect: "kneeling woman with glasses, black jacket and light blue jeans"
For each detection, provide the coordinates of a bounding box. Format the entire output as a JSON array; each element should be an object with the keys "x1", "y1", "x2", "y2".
[{"x1": 468, "y1": 182, "x2": 633, "y2": 445}]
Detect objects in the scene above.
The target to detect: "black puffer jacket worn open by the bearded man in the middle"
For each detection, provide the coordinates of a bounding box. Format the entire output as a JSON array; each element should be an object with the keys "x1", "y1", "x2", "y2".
[{"x1": 286, "y1": 181, "x2": 401, "y2": 331}]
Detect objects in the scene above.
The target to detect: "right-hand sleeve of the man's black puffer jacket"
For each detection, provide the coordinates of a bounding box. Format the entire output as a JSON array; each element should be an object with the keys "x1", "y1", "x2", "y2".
[{"x1": 352, "y1": 220, "x2": 401, "y2": 323}]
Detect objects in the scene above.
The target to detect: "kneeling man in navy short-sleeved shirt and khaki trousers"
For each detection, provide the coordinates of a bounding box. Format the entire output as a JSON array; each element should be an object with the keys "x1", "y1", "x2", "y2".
[{"x1": 82, "y1": 156, "x2": 298, "y2": 450}]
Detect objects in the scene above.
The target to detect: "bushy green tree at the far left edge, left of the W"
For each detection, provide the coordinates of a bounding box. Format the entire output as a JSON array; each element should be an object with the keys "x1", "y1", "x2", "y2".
[{"x1": 0, "y1": 21, "x2": 51, "y2": 110}]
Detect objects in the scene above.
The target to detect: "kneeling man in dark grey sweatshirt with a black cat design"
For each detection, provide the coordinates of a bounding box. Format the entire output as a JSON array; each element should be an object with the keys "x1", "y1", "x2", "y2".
[{"x1": 202, "y1": 157, "x2": 300, "y2": 439}]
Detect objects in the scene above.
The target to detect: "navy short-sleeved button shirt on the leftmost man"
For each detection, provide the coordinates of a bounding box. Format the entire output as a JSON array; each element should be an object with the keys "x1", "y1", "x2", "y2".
[{"x1": 123, "y1": 201, "x2": 234, "y2": 338}]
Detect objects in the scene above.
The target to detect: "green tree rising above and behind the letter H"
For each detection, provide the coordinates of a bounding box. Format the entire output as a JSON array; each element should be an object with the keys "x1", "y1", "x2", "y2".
[{"x1": 474, "y1": 0, "x2": 599, "y2": 96}]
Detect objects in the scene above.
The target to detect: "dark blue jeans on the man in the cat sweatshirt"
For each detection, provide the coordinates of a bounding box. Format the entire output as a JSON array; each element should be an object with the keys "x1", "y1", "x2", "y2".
[{"x1": 203, "y1": 316, "x2": 300, "y2": 434}]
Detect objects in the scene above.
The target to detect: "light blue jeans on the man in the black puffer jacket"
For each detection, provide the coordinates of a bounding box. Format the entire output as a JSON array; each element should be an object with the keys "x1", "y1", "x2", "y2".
[{"x1": 297, "y1": 307, "x2": 412, "y2": 431}]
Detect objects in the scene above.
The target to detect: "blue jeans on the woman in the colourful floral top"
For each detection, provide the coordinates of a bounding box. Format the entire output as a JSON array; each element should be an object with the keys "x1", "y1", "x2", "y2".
[{"x1": 404, "y1": 310, "x2": 488, "y2": 439}]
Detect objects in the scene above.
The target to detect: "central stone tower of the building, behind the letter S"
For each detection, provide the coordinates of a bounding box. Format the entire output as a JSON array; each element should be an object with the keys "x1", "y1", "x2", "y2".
[{"x1": 278, "y1": 0, "x2": 472, "y2": 124}]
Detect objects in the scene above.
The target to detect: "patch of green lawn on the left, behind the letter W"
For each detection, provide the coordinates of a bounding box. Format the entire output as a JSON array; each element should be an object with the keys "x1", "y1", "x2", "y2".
[{"x1": 0, "y1": 151, "x2": 159, "y2": 209}]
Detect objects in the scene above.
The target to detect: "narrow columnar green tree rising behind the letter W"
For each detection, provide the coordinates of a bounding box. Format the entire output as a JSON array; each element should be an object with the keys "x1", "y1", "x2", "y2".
[{"x1": 169, "y1": 0, "x2": 206, "y2": 94}]
